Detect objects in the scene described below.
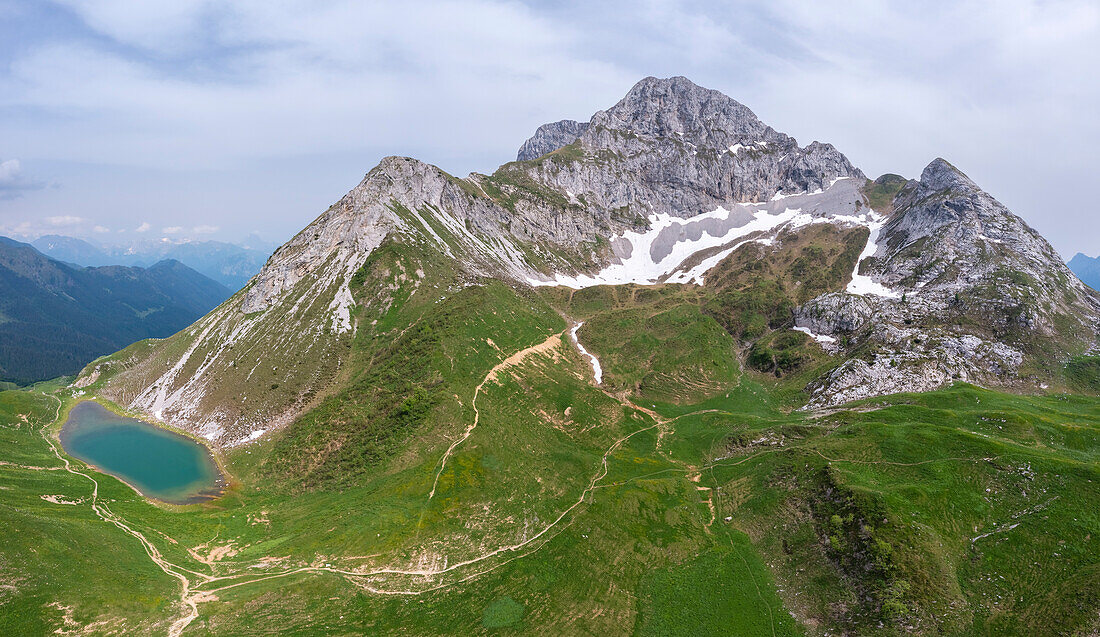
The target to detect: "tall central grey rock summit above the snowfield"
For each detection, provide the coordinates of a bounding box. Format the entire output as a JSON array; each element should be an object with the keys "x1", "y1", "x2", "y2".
[{"x1": 510, "y1": 77, "x2": 864, "y2": 227}]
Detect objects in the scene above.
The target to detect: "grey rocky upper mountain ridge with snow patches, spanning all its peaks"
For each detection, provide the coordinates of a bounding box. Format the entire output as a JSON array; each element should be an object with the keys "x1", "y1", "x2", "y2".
[{"x1": 78, "y1": 77, "x2": 1100, "y2": 446}]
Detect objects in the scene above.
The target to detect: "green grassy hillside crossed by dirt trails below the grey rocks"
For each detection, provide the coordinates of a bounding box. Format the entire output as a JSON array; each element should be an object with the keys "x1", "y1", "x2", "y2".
[{"x1": 0, "y1": 244, "x2": 1100, "y2": 635}]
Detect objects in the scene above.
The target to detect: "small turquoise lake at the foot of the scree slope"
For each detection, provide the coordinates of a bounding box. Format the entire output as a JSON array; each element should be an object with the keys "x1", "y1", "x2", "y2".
[{"x1": 61, "y1": 400, "x2": 224, "y2": 504}]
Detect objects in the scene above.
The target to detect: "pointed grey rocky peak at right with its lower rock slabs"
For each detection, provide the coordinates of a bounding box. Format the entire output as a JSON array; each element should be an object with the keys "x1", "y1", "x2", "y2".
[{"x1": 795, "y1": 160, "x2": 1100, "y2": 406}]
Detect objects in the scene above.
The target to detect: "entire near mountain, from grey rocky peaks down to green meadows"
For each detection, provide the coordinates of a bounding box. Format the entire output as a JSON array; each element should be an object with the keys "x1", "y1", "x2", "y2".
[{"x1": 0, "y1": 77, "x2": 1100, "y2": 637}]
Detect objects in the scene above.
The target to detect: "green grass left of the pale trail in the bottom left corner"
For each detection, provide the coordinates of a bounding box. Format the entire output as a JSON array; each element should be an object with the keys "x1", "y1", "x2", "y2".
[{"x1": 0, "y1": 391, "x2": 177, "y2": 635}]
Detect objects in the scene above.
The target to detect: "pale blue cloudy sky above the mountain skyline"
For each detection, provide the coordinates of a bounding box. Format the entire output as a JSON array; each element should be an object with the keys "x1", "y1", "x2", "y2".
[{"x1": 0, "y1": 0, "x2": 1100, "y2": 256}]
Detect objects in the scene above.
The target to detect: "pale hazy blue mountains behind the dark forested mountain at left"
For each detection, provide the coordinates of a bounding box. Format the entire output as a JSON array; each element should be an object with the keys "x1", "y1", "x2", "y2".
[{"x1": 31, "y1": 234, "x2": 273, "y2": 290}]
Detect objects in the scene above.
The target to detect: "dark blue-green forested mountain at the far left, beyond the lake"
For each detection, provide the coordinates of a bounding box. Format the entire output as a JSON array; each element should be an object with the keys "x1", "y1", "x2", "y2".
[{"x1": 0, "y1": 237, "x2": 231, "y2": 383}]
